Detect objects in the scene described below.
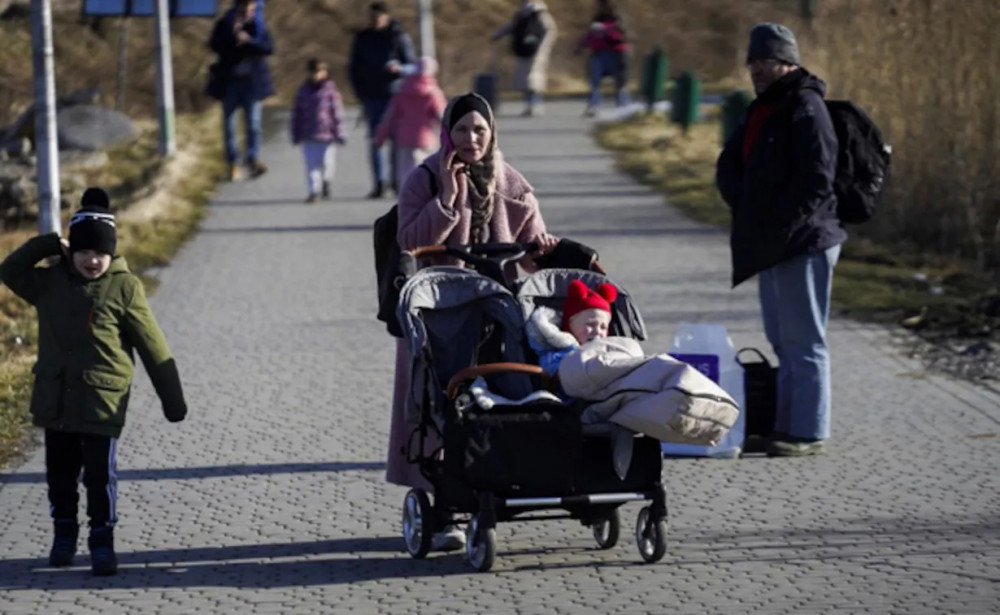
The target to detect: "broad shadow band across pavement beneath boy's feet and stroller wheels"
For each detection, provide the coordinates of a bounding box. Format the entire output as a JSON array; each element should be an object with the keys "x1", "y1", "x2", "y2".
[{"x1": 0, "y1": 516, "x2": 1000, "y2": 591}]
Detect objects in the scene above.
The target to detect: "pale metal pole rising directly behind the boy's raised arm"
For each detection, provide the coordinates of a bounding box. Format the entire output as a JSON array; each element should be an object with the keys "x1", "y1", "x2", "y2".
[{"x1": 31, "y1": 0, "x2": 62, "y2": 234}]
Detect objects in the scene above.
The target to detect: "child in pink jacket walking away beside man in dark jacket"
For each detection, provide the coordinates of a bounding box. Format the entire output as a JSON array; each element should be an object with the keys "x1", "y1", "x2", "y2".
[{"x1": 375, "y1": 57, "x2": 447, "y2": 194}]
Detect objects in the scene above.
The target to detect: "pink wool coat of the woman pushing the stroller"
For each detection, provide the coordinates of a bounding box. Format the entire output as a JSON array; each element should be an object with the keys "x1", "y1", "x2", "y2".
[{"x1": 386, "y1": 152, "x2": 545, "y2": 489}]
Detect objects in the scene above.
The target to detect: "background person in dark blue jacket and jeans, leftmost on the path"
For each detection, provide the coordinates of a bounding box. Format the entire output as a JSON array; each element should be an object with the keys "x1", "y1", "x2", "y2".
[{"x1": 206, "y1": 0, "x2": 274, "y2": 181}]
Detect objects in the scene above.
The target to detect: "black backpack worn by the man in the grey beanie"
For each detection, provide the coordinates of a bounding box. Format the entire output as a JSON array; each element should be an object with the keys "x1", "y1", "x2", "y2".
[{"x1": 826, "y1": 100, "x2": 892, "y2": 224}]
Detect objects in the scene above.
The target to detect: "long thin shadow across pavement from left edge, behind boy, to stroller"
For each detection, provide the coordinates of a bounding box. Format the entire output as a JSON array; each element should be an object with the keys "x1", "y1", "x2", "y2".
[{"x1": 0, "y1": 461, "x2": 385, "y2": 485}]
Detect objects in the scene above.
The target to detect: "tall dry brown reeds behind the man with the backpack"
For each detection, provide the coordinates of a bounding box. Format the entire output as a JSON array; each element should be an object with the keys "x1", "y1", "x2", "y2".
[{"x1": 805, "y1": 0, "x2": 1000, "y2": 281}]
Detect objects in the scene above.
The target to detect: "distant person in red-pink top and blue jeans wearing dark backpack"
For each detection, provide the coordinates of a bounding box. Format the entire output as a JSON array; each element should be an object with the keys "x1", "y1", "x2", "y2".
[{"x1": 575, "y1": 0, "x2": 629, "y2": 117}]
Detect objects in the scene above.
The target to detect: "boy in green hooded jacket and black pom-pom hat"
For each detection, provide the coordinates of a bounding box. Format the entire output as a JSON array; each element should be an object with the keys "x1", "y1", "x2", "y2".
[{"x1": 0, "y1": 188, "x2": 187, "y2": 575}]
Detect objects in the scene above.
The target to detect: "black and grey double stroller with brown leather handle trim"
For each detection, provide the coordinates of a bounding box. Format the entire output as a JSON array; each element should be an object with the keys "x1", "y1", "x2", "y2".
[{"x1": 397, "y1": 244, "x2": 667, "y2": 571}]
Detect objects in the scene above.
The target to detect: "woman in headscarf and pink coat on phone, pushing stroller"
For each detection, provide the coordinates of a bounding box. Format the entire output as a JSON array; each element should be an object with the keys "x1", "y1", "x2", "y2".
[{"x1": 386, "y1": 94, "x2": 559, "y2": 550}]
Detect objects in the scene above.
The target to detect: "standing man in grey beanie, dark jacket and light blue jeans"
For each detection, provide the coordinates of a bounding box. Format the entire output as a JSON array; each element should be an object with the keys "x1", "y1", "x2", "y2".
[{"x1": 716, "y1": 23, "x2": 847, "y2": 456}]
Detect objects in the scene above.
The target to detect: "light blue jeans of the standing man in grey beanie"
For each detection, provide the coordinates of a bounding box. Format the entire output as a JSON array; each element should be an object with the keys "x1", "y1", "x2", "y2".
[{"x1": 758, "y1": 246, "x2": 840, "y2": 440}]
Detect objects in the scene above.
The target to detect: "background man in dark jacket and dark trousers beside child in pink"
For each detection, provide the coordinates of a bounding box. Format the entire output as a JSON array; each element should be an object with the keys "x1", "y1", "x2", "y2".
[{"x1": 348, "y1": 2, "x2": 417, "y2": 199}]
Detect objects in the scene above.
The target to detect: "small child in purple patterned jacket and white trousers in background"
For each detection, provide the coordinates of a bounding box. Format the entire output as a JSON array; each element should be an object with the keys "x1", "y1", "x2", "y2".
[{"x1": 291, "y1": 59, "x2": 345, "y2": 203}]
